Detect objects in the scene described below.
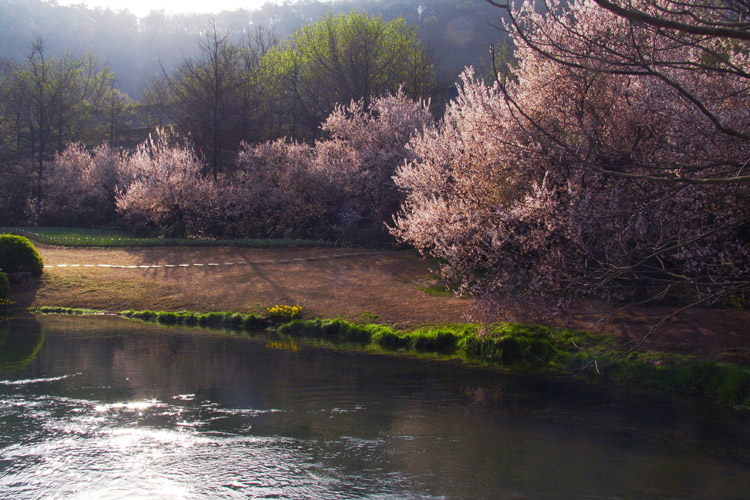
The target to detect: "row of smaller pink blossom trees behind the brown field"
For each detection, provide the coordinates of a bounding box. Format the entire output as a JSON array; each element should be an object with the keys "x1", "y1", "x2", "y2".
[{"x1": 47, "y1": 92, "x2": 433, "y2": 244}]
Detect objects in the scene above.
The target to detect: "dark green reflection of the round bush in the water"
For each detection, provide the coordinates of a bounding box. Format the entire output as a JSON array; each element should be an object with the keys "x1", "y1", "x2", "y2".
[{"x1": 0, "y1": 317, "x2": 44, "y2": 374}]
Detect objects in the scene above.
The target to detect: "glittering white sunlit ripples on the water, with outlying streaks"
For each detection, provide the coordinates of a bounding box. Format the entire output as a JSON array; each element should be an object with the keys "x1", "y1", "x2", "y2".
[{"x1": 0, "y1": 396, "x2": 424, "y2": 500}]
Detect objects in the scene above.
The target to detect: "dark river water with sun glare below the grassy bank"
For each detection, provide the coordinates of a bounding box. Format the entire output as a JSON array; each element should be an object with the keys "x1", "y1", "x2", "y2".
[{"x1": 0, "y1": 316, "x2": 750, "y2": 500}]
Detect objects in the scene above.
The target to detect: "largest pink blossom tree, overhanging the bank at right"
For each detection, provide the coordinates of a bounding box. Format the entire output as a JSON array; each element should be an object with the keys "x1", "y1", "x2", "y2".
[{"x1": 393, "y1": 0, "x2": 750, "y2": 312}]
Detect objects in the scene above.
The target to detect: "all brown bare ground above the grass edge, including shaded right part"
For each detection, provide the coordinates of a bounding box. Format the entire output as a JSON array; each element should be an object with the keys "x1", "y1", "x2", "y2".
[{"x1": 12, "y1": 245, "x2": 750, "y2": 361}]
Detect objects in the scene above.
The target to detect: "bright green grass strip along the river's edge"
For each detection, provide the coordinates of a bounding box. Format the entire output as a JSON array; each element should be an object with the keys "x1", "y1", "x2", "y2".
[{"x1": 26, "y1": 307, "x2": 750, "y2": 411}]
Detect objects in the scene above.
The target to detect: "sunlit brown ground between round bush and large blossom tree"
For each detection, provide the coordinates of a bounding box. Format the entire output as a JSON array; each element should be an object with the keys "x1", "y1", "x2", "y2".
[{"x1": 14, "y1": 245, "x2": 469, "y2": 326}]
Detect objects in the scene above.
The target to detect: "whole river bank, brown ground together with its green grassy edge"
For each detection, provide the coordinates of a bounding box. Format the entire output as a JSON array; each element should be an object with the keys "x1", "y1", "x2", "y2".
[{"x1": 1, "y1": 234, "x2": 750, "y2": 410}]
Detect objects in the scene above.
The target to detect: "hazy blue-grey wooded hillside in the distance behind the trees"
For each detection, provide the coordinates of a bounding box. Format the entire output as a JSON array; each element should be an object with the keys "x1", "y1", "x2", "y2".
[{"x1": 0, "y1": 0, "x2": 505, "y2": 99}]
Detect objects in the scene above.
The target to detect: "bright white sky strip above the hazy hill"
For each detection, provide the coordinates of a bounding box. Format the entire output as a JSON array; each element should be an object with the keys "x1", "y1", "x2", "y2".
[{"x1": 57, "y1": 0, "x2": 279, "y2": 16}]
